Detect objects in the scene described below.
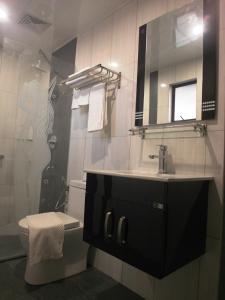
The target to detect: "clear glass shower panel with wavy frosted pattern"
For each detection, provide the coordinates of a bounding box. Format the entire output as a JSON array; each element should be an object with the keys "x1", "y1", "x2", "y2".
[{"x1": 0, "y1": 0, "x2": 54, "y2": 261}]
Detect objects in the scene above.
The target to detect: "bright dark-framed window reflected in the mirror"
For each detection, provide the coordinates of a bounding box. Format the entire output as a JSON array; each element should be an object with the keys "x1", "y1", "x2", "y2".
[{"x1": 171, "y1": 79, "x2": 197, "y2": 122}]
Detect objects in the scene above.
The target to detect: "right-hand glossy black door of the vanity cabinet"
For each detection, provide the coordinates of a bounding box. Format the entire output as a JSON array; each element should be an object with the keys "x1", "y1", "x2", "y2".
[{"x1": 111, "y1": 177, "x2": 166, "y2": 277}]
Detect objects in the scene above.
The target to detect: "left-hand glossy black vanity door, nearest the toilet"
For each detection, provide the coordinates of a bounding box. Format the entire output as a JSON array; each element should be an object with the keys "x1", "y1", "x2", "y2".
[{"x1": 84, "y1": 174, "x2": 117, "y2": 254}]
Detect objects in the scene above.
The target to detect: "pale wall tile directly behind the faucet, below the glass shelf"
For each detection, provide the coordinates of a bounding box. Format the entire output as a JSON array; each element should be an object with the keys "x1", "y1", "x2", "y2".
[{"x1": 129, "y1": 134, "x2": 206, "y2": 175}]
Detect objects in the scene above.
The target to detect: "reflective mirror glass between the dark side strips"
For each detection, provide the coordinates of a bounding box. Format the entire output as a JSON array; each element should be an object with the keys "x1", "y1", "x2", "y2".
[{"x1": 143, "y1": 1, "x2": 203, "y2": 125}]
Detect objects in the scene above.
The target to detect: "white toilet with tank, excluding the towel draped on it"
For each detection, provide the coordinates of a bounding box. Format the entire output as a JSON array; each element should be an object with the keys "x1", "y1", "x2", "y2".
[{"x1": 18, "y1": 180, "x2": 88, "y2": 285}]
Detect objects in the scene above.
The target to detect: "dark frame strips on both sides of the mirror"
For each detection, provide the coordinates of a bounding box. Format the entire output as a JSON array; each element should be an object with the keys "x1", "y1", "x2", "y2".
[{"x1": 135, "y1": 0, "x2": 219, "y2": 127}]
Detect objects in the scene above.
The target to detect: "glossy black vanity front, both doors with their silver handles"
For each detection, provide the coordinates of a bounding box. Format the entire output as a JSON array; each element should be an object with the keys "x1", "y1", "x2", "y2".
[{"x1": 84, "y1": 174, "x2": 167, "y2": 278}]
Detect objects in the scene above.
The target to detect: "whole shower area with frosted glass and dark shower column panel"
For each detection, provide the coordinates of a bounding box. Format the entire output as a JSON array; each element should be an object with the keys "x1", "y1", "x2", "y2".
[{"x1": 0, "y1": 0, "x2": 76, "y2": 261}]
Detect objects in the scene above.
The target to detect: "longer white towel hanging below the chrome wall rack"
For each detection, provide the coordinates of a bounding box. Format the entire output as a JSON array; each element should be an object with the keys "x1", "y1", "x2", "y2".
[{"x1": 88, "y1": 83, "x2": 106, "y2": 132}]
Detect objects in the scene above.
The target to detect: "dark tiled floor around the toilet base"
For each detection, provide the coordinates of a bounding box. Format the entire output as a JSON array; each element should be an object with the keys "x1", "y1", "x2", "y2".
[{"x1": 0, "y1": 258, "x2": 143, "y2": 300}]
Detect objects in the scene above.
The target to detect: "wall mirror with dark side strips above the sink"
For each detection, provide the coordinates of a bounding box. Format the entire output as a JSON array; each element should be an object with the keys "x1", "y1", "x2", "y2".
[{"x1": 135, "y1": 0, "x2": 217, "y2": 126}]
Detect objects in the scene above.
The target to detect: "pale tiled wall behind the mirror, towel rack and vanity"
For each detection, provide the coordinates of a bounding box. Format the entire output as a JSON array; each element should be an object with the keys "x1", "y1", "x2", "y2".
[{"x1": 69, "y1": 0, "x2": 225, "y2": 300}]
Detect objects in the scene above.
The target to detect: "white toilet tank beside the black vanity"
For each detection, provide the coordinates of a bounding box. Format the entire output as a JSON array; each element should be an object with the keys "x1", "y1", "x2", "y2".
[{"x1": 67, "y1": 180, "x2": 86, "y2": 223}]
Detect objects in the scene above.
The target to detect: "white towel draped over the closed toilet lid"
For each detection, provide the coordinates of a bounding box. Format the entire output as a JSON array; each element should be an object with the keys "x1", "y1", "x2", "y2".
[{"x1": 26, "y1": 212, "x2": 64, "y2": 265}]
